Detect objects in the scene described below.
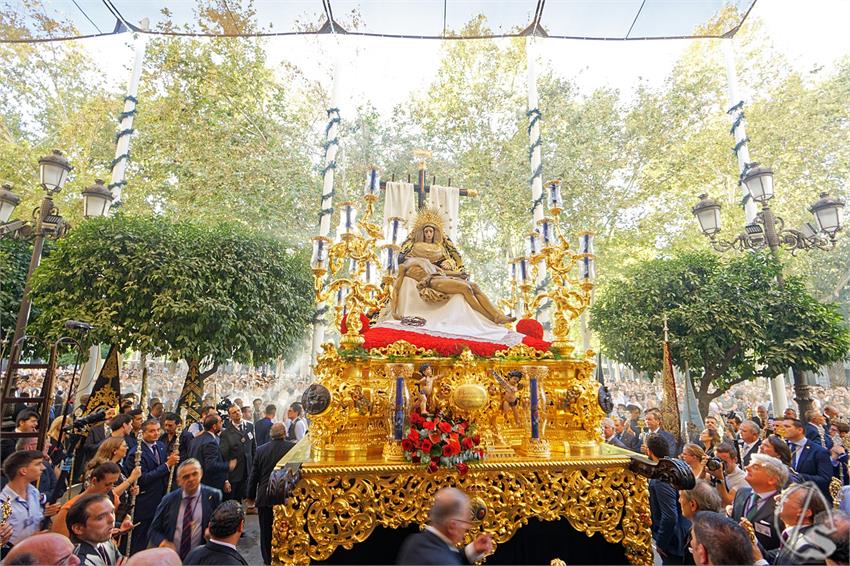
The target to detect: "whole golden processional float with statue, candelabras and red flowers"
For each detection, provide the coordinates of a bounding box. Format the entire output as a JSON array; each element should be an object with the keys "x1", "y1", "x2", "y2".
[{"x1": 270, "y1": 165, "x2": 682, "y2": 564}]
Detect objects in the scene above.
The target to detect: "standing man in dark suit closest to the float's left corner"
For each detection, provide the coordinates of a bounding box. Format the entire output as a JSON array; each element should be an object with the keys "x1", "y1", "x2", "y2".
[{"x1": 246, "y1": 423, "x2": 295, "y2": 564}]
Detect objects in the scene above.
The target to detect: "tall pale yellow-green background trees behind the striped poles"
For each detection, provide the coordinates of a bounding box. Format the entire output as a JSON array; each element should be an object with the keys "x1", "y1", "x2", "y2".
[{"x1": 0, "y1": 2, "x2": 850, "y2": 368}]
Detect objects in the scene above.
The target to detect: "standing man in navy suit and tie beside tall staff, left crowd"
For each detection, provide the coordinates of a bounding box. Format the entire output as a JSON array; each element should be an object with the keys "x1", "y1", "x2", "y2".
[{"x1": 124, "y1": 419, "x2": 179, "y2": 554}]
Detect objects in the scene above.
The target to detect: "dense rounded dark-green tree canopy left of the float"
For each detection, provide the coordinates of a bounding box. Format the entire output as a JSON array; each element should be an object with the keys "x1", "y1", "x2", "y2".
[{"x1": 33, "y1": 214, "x2": 313, "y2": 374}]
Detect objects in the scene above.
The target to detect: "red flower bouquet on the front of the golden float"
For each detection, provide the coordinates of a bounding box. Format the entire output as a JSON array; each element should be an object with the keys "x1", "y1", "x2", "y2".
[{"x1": 401, "y1": 411, "x2": 484, "y2": 475}]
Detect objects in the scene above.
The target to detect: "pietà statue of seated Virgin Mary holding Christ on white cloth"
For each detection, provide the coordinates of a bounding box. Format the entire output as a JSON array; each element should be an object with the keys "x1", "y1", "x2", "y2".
[{"x1": 378, "y1": 208, "x2": 522, "y2": 345}]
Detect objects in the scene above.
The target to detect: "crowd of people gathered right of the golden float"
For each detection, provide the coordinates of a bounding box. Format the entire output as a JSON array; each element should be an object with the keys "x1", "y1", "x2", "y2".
[{"x1": 603, "y1": 390, "x2": 850, "y2": 566}]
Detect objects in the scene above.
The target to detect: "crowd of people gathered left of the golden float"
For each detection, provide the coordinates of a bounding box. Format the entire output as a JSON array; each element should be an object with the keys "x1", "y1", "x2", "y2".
[{"x1": 0, "y1": 364, "x2": 309, "y2": 566}]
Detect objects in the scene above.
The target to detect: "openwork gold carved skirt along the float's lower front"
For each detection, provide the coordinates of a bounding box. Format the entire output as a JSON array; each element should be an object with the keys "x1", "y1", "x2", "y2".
[{"x1": 273, "y1": 460, "x2": 652, "y2": 565}]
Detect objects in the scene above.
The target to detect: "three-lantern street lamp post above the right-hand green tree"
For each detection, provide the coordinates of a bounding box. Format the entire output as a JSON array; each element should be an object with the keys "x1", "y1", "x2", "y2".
[{"x1": 692, "y1": 163, "x2": 844, "y2": 418}]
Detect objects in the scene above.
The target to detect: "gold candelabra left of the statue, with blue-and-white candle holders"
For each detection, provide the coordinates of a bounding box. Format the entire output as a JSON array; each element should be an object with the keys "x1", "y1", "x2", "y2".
[{"x1": 312, "y1": 192, "x2": 388, "y2": 349}]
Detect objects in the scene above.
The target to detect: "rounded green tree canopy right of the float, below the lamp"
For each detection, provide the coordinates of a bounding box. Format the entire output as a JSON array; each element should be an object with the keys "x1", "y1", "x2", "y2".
[{"x1": 591, "y1": 252, "x2": 850, "y2": 414}]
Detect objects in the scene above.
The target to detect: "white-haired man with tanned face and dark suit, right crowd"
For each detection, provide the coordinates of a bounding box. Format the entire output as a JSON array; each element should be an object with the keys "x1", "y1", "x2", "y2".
[{"x1": 732, "y1": 454, "x2": 788, "y2": 550}]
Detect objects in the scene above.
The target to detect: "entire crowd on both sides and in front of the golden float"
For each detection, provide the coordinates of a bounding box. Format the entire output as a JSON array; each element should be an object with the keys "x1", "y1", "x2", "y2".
[{"x1": 0, "y1": 362, "x2": 850, "y2": 566}]
